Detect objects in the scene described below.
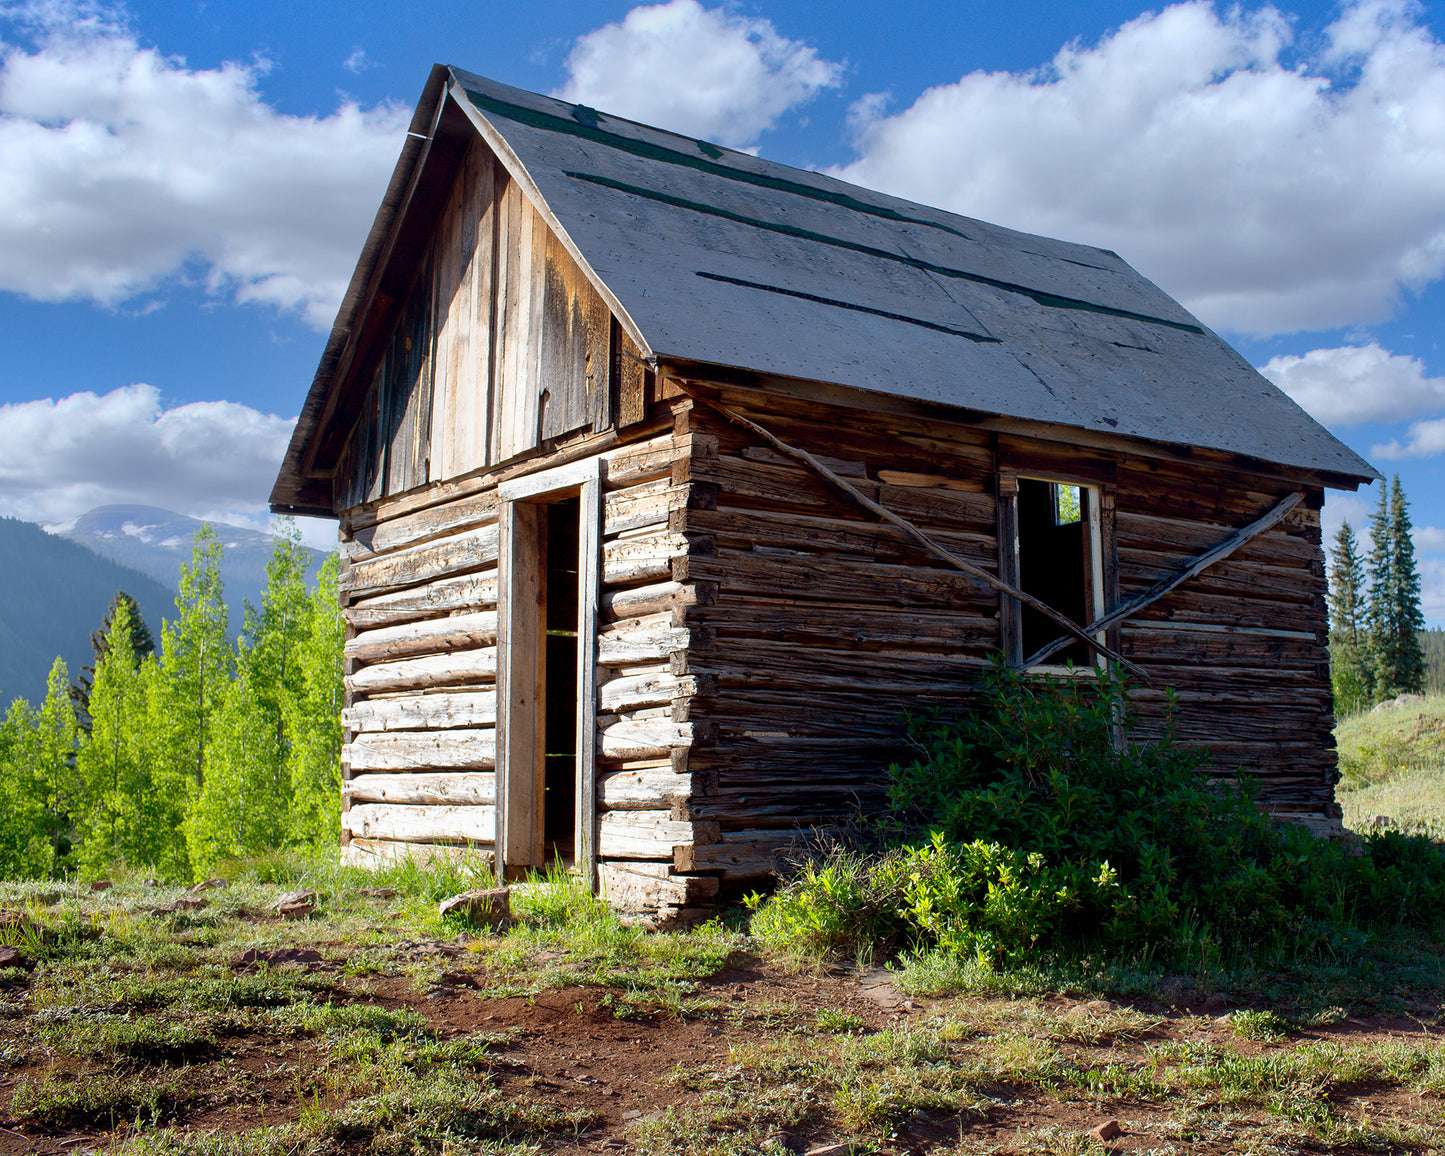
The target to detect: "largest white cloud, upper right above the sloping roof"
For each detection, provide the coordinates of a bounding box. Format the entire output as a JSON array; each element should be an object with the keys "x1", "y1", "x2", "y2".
[{"x1": 838, "y1": 0, "x2": 1445, "y2": 334}]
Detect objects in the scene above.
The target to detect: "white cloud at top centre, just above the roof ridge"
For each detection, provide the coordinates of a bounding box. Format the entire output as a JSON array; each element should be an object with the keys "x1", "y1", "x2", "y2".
[{"x1": 555, "y1": 0, "x2": 844, "y2": 147}]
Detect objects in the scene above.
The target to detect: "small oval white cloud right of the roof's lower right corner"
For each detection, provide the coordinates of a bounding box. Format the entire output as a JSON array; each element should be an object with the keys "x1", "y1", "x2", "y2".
[{"x1": 1260, "y1": 341, "x2": 1445, "y2": 426}]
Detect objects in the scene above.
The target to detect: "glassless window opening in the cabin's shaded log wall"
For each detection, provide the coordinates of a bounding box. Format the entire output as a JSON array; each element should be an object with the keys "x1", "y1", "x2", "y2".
[{"x1": 1004, "y1": 478, "x2": 1104, "y2": 668}]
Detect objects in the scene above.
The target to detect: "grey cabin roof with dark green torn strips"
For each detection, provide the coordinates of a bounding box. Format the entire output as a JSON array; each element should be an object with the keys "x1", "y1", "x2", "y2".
[{"x1": 272, "y1": 68, "x2": 1379, "y2": 504}]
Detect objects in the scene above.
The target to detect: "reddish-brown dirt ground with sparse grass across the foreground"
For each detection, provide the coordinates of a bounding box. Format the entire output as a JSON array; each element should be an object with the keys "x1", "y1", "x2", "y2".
[{"x1": 0, "y1": 887, "x2": 1445, "y2": 1156}]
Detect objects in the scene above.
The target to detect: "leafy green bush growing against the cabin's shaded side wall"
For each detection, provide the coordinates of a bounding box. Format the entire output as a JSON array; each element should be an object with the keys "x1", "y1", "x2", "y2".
[{"x1": 754, "y1": 663, "x2": 1445, "y2": 967}]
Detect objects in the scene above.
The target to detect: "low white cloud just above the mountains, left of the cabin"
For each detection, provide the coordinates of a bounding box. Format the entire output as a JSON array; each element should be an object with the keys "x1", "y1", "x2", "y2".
[{"x1": 0, "y1": 384, "x2": 297, "y2": 536}]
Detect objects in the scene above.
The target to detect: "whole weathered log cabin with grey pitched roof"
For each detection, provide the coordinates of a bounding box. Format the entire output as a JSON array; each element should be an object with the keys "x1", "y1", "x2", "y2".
[{"x1": 272, "y1": 66, "x2": 1377, "y2": 915}]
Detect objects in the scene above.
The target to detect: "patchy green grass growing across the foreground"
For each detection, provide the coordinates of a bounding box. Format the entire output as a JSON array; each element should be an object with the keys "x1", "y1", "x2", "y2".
[{"x1": 0, "y1": 861, "x2": 1445, "y2": 1156}]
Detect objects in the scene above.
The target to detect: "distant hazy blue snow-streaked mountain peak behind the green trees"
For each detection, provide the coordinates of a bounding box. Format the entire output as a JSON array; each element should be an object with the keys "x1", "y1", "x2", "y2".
[{"x1": 46, "y1": 506, "x2": 327, "y2": 642}]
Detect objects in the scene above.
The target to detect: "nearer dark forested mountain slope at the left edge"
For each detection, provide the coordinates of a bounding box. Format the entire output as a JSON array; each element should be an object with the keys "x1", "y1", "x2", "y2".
[{"x1": 0, "y1": 517, "x2": 175, "y2": 711}]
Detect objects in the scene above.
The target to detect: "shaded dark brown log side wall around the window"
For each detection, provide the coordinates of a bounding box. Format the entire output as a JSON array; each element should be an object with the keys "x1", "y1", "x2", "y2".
[{"x1": 672, "y1": 383, "x2": 1338, "y2": 880}]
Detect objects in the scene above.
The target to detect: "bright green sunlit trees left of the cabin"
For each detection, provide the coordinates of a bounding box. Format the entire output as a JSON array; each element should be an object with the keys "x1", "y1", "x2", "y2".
[{"x1": 0, "y1": 526, "x2": 344, "y2": 880}]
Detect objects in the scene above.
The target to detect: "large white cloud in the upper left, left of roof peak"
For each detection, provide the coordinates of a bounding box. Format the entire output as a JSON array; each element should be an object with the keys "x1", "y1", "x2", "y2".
[{"x1": 0, "y1": 3, "x2": 406, "y2": 328}]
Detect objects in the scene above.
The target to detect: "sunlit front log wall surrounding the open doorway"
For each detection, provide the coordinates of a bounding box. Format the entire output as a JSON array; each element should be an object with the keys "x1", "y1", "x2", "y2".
[{"x1": 341, "y1": 405, "x2": 717, "y2": 916}]
